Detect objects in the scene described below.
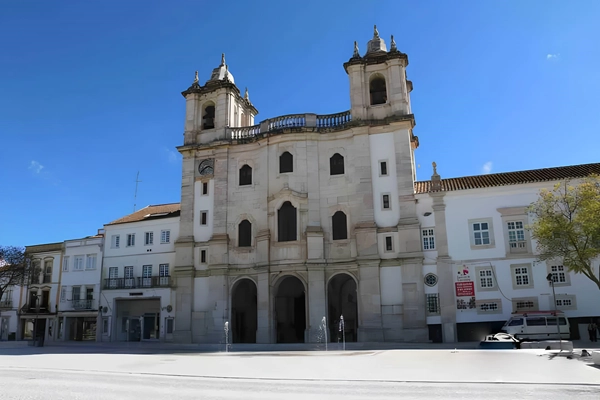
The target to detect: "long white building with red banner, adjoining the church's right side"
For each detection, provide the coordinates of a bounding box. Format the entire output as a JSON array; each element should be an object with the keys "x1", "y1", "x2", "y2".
[{"x1": 415, "y1": 164, "x2": 600, "y2": 342}]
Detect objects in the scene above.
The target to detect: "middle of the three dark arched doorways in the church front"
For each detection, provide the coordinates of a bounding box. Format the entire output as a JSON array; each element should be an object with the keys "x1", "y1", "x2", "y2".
[{"x1": 275, "y1": 276, "x2": 306, "y2": 343}]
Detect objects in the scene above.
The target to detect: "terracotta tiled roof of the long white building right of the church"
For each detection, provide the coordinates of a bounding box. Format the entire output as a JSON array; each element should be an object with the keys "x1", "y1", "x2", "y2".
[{"x1": 415, "y1": 163, "x2": 600, "y2": 193}]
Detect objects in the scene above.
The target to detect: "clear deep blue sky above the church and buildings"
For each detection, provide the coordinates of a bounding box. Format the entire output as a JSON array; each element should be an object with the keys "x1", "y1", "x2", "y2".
[{"x1": 0, "y1": 0, "x2": 600, "y2": 245}]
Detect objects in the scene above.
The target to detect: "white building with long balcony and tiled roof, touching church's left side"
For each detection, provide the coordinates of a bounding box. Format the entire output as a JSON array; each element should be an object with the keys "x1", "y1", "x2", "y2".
[{"x1": 100, "y1": 204, "x2": 179, "y2": 341}]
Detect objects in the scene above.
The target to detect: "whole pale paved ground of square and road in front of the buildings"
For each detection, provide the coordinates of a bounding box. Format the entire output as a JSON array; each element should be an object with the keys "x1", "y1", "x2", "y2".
[{"x1": 0, "y1": 349, "x2": 600, "y2": 400}]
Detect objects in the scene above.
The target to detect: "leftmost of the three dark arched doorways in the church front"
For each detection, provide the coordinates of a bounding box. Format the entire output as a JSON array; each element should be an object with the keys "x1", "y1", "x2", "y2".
[{"x1": 231, "y1": 279, "x2": 257, "y2": 343}]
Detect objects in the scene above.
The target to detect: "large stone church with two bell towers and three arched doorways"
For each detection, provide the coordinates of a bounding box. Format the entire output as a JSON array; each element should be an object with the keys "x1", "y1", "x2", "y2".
[{"x1": 174, "y1": 28, "x2": 428, "y2": 343}]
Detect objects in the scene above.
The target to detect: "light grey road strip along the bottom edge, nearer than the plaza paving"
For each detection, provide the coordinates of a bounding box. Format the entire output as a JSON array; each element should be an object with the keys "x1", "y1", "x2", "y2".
[{"x1": 0, "y1": 369, "x2": 600, "y2": 400}]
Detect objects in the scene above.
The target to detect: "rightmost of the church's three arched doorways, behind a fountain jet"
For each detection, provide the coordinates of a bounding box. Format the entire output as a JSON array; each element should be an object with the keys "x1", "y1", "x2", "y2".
[{"x1": 327, "y1": 274, "x2": 358, "y2": 342}]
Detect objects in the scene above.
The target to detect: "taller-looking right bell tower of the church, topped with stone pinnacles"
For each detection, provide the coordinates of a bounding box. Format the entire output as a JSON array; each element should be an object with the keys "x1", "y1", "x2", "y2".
[{"x1": 344, "y1": 26, "x2": 412, "y2": 120}]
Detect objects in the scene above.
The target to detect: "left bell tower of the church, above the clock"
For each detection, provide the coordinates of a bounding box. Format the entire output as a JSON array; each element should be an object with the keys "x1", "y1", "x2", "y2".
[{"x1": 181, "y1": 54, "x2": 258, "y2": 145}]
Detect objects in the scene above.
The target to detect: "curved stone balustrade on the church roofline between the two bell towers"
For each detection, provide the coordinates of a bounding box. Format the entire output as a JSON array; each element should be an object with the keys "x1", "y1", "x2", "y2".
[{"x1": 229, "y1": 111, "x2": 352, "y2": 140}]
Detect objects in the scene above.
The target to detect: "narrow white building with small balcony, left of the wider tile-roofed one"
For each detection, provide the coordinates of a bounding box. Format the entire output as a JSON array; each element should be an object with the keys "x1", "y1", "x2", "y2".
[{"x1": 57, "y1": 232, "x2": 104, "y2": 341}]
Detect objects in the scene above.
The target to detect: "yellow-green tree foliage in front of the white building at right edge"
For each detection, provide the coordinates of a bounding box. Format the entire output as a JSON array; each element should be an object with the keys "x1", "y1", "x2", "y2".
[{"x1": 529, "y1": 176, "x2": 600, "y2": 289}]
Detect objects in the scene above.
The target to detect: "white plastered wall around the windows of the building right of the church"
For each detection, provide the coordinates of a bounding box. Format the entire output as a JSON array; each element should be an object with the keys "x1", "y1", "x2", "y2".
[{"x1": 417, "y1": 182, "x2": 600, "y2": 333}]
